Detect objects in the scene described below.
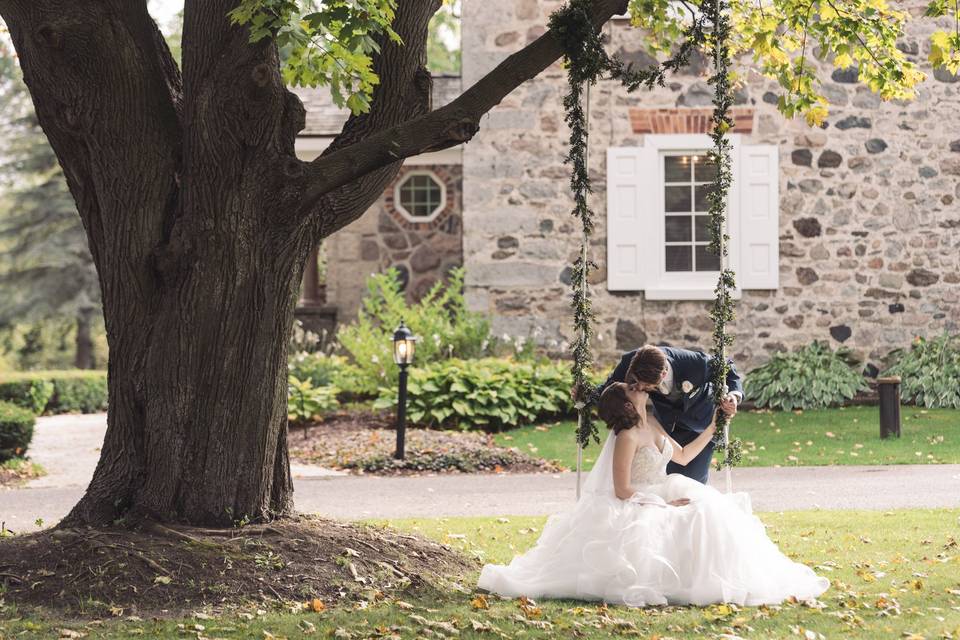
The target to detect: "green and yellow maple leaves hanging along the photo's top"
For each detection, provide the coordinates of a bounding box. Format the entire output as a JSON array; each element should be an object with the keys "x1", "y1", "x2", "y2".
[{"x1": 231, "y1": 0, "x2": 960, "y2": 125}]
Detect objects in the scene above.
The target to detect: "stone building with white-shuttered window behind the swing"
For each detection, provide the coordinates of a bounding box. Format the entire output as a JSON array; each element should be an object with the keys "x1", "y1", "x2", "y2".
[{"x1": 302, "y1": 0, "x2": 960, "y2": 368}]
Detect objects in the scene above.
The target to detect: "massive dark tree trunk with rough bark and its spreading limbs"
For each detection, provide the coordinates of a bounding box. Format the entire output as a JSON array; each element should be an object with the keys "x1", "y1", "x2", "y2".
[{"x1": 0, "y1": 0, "x2": 626, "y2": 525}]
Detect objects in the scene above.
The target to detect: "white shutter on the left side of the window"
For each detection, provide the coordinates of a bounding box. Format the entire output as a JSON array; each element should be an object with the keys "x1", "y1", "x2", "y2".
[{"x1": 607, "y1": 147, "x2": 656, "y2": 291}]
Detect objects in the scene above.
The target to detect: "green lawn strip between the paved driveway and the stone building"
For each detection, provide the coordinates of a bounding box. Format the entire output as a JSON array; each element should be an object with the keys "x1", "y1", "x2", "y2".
[{"x1": 495, "y1": 407, "x2": 960, "y2": 469}]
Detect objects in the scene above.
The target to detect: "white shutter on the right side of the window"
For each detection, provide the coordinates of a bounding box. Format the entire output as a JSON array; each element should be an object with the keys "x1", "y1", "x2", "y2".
[{"x1": 730, "y1": 144, "x2": 780, "y2": 289}]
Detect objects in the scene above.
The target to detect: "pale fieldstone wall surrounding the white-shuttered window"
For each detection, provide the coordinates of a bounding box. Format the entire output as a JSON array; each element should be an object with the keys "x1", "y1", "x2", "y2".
[{"x1": 463, "y1": 0, "x2": 960, "y2": 368}]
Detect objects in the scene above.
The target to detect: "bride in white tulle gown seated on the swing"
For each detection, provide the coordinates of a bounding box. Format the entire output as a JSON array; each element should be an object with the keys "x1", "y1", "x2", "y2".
[{"x1": 478, "y1": 383, "x2": 829, "y2": 607}]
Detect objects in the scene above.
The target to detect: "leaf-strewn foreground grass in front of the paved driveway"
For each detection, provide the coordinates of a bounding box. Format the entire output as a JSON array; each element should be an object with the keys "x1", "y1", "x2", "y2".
[{"x1": 0, "y1": 509, "x2": 960, "y2": 640}]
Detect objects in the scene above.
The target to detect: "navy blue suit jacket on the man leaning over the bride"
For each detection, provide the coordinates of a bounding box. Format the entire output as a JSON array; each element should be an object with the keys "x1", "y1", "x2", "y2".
[{"x1": 597, "y1": 347, "x2": 743, "y2": 432}]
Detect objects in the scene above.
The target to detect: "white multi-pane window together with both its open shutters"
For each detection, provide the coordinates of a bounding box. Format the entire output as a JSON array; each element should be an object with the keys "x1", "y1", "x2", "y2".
[{"x1": 607, "y1": 134, "x2": 779, "y2": 300}]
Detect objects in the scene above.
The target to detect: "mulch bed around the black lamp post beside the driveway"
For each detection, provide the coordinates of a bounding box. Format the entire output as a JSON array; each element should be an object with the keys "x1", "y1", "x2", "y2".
[{"x1": 288, "y1": 410, "x2": 562, "y2": 475}]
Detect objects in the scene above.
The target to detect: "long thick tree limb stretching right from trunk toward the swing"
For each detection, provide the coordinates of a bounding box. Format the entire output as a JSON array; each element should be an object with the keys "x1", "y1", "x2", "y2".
[{"x1": 298, "y1": 0, "x2": 627, "y2": 228}]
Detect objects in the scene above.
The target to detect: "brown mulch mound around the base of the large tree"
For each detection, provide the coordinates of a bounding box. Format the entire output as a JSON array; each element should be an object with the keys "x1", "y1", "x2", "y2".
[{"x1": 0, "y1": 516, "x2": 477, "y2": 617}]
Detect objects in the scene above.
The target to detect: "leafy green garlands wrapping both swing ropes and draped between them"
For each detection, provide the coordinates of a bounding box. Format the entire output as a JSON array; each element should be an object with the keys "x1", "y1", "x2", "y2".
[{"x1": 549, "y1": 0, "x2": 740, "y2": 466}]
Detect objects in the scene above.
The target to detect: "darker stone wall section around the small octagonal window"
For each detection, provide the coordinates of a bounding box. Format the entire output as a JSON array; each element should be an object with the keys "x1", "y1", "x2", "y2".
[{"x1": 326, "y1": 164, "x2": 463, "y2": 322}]
